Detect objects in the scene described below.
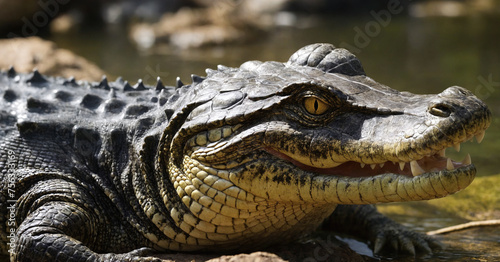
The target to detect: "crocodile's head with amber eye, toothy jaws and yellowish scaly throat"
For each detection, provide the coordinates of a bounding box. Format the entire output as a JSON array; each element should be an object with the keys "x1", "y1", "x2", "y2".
[{"x1": 159, "y1": 44, "x2": 490, "y2": 250}]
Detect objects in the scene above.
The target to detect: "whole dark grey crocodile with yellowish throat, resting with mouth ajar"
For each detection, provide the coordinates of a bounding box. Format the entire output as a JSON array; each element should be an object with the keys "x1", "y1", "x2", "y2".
[{"x1": 0, "y1": 44, "x2": 491, "y2": 261}]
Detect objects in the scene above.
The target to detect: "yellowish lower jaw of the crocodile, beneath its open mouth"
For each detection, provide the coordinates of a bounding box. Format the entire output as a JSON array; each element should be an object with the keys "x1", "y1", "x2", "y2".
[{"x1": 302, "y1": 165, "x2": 476, "y2": 205}]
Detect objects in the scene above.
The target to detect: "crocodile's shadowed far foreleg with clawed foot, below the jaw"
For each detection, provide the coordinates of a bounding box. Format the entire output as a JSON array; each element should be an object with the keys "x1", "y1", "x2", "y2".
[{"x1": 324, "y1": 205, "x2": 442, "y2": 255}]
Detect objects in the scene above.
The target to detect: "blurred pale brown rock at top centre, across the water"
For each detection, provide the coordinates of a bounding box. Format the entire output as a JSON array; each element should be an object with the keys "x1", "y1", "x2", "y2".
[{"x1": 130, "y1": 1, "x2": 273, "y2": 49}]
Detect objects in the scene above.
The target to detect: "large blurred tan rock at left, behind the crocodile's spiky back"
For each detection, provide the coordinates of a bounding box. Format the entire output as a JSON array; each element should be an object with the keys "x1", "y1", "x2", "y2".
[{"x1": 0, "y1": 37, "x2": 105, "y2": 81}]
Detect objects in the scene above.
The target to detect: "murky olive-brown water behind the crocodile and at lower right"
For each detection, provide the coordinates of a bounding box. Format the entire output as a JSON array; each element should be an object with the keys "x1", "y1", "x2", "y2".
[{"x1": 47, "y1": 12, "x2": 500, "y2": 261}]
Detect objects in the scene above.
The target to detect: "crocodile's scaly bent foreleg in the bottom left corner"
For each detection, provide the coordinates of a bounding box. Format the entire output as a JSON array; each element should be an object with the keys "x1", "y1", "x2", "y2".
[{"x1": 11, "y1": 201, "x2": 161, "y2": 262}]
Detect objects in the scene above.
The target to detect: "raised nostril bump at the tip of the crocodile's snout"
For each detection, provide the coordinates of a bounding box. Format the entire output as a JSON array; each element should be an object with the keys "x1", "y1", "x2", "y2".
[{"x1": 429, "y1": 86, "x2": 485, "y2": 117}]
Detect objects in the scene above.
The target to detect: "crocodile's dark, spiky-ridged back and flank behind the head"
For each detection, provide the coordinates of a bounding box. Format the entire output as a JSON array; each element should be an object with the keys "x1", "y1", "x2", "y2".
[{"x1": 0, "y1": 68, "x2": 178, "y2": 254}]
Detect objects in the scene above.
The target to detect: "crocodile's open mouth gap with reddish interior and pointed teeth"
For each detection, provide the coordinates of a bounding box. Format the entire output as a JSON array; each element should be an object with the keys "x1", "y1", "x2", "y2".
[{"x1": 266, "y1": 131, "x2": 484, "y2": 177}]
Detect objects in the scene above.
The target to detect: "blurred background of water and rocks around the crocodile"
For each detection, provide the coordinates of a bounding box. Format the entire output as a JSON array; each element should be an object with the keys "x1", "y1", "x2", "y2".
[{"x1": 0, "y1": 0, "x2": 500, "y2": 257}]
